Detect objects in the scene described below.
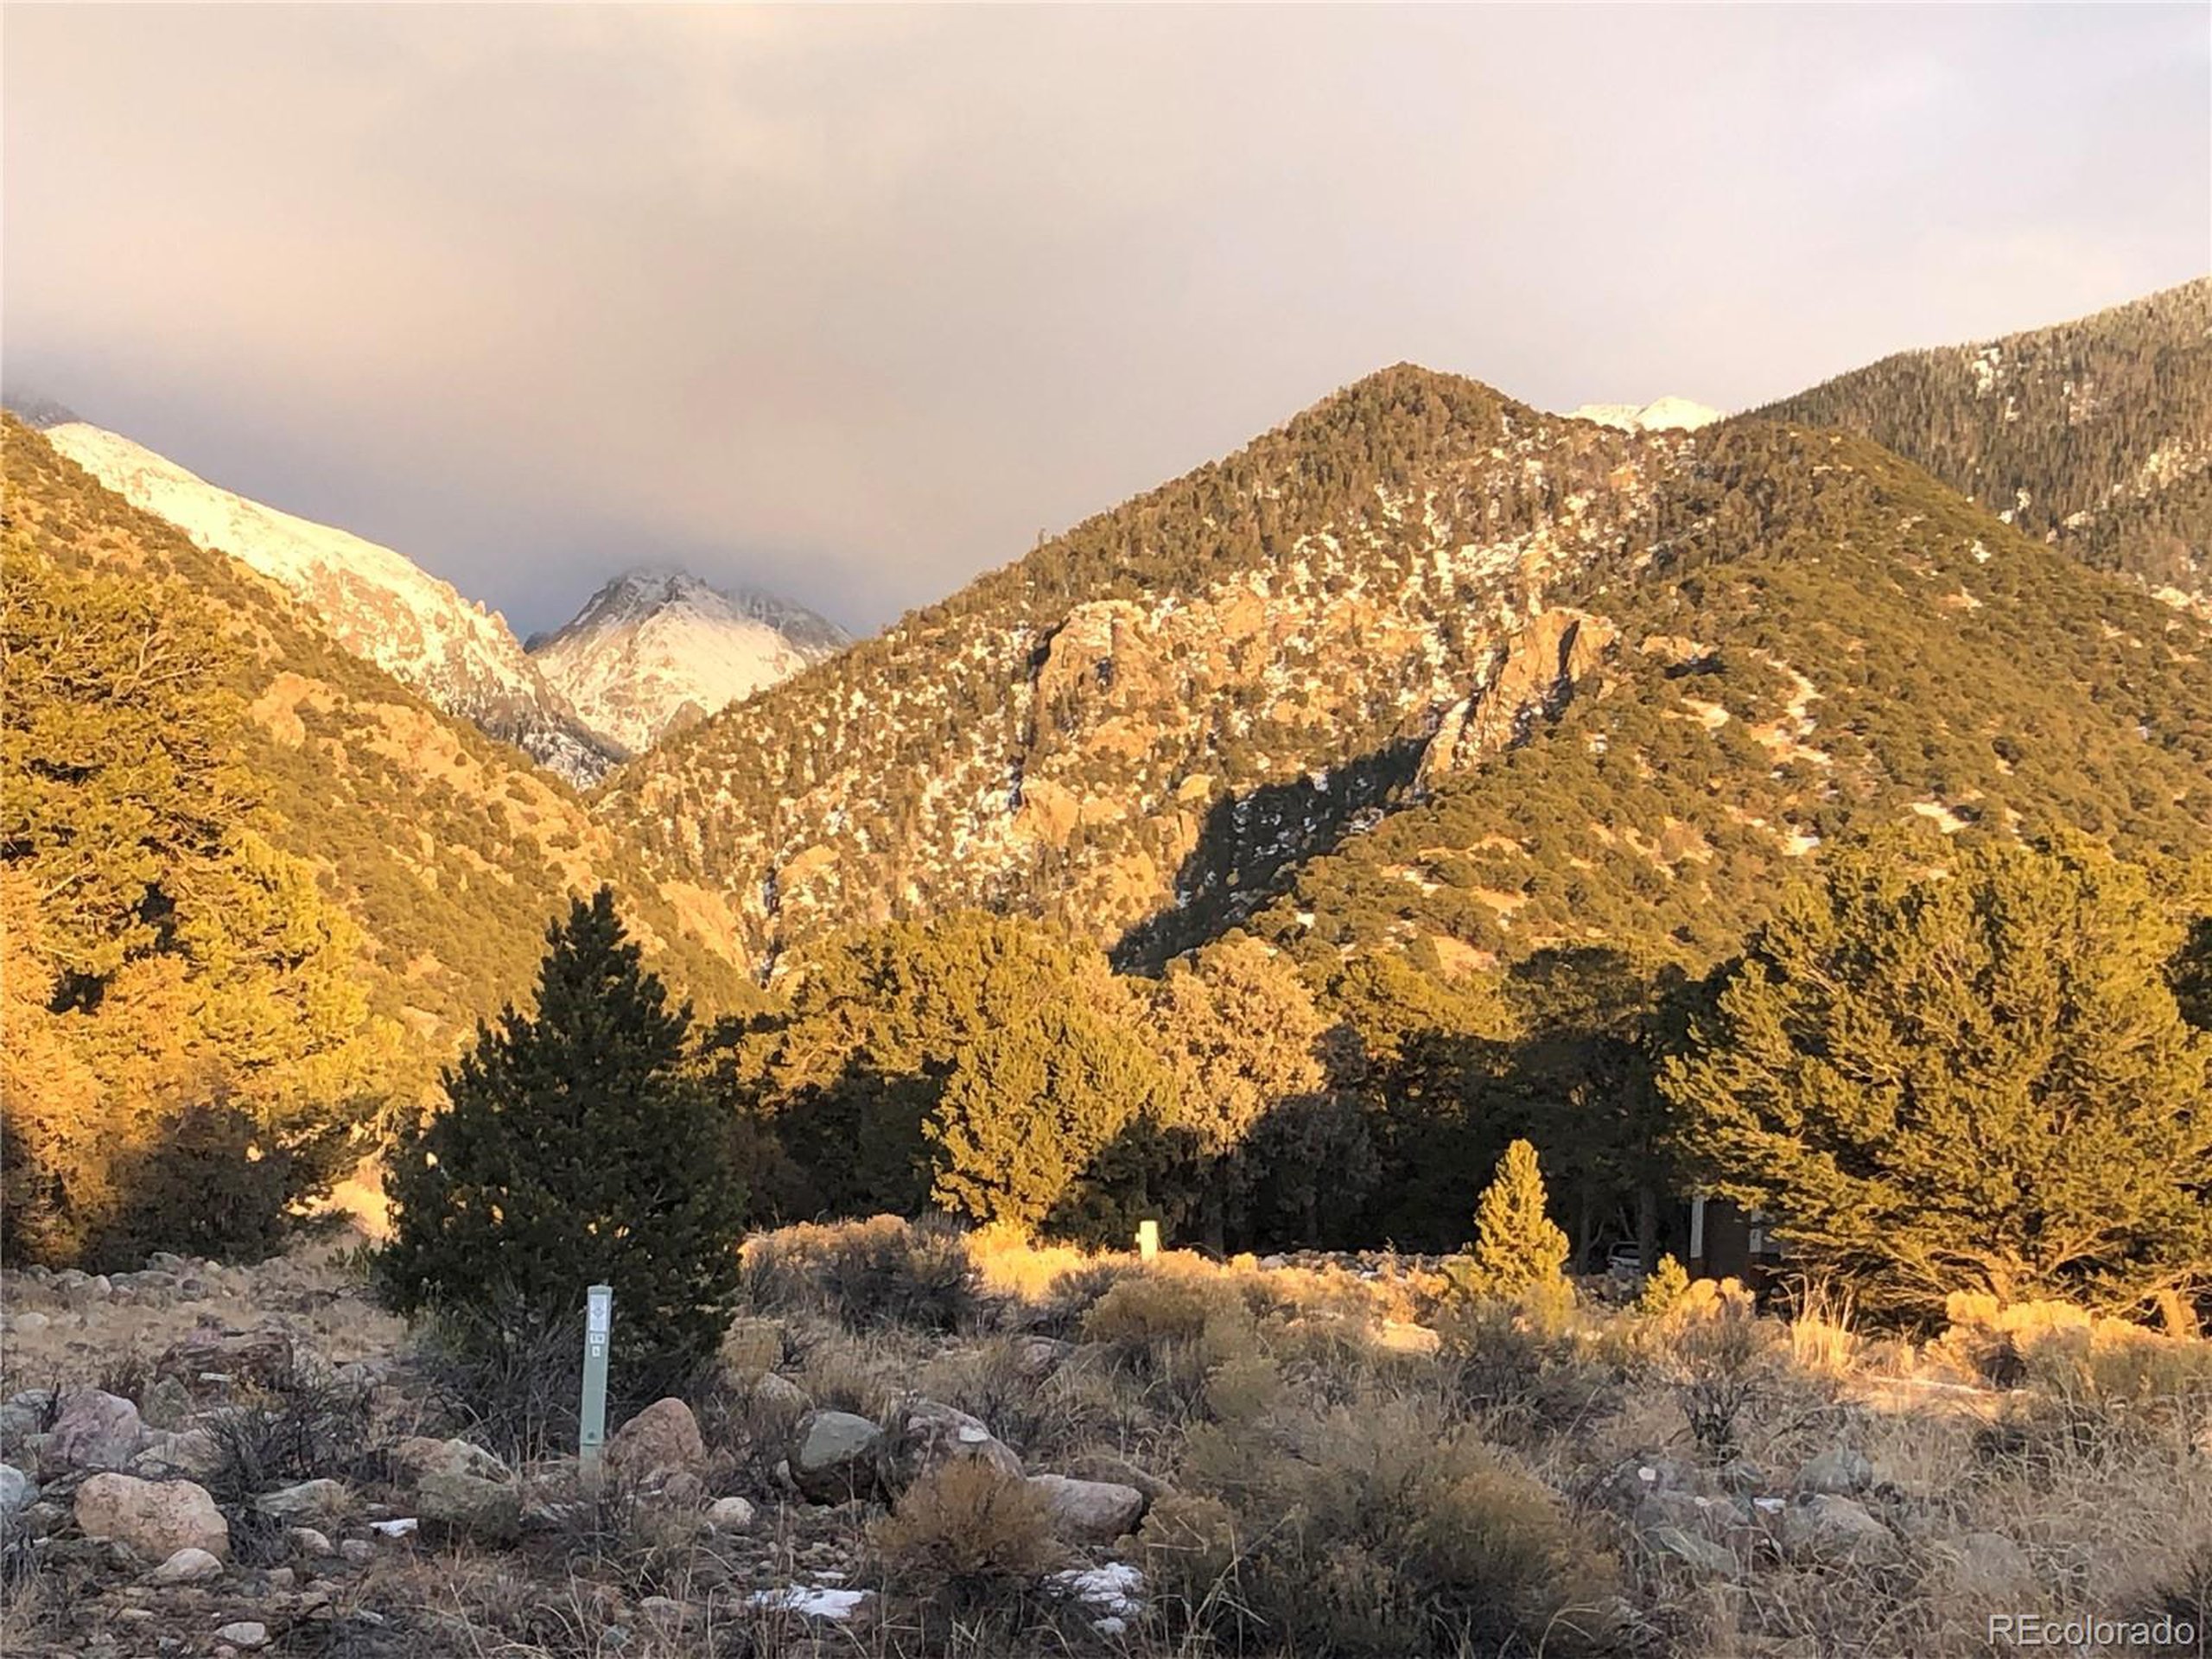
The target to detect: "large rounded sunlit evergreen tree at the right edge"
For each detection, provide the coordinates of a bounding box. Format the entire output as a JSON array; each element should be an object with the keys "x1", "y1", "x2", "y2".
[{"x1": 1663, "y1": 838, "x2": 2212, "y2": 1314}]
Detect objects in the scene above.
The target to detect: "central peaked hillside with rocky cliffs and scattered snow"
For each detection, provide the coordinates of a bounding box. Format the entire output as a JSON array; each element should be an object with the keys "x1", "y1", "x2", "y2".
[{"x1": 600, "y1": 367, "x2": 1692, "y2": 967}]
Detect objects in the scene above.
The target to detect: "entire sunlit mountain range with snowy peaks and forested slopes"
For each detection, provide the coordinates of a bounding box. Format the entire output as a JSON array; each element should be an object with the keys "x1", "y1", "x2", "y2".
[{"x1": 7, "y1": 281, "x2": 2212, "y2": 1106}]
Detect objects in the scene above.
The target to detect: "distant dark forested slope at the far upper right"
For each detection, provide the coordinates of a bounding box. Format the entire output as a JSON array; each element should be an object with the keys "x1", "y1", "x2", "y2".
[{"x1": 1758, "y1": 276, "x2": 2212, "y2": 606}]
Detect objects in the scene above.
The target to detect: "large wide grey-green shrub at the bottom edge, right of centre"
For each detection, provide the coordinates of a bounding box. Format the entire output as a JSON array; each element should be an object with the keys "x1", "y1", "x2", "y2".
[{"x1": 1141, "y1": 1398, "x2": 1612, "y2": 1659}]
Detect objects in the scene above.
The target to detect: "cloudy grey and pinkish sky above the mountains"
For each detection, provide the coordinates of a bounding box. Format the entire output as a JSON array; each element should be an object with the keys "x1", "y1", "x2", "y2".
[{"x1": 0, "y1": 4, "x2": 2212, "y2": 632}]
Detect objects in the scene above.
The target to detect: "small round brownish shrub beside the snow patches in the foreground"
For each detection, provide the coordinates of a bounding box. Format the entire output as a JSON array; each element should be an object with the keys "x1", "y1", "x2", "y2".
[{"x1": 868, "y1": 1458, "x2": 1064, "y2": 1624}]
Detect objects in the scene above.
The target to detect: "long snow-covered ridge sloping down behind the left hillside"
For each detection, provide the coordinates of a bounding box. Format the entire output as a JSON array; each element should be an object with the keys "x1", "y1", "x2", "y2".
[{"x1": 47, "y1": 420, "x2": 620, "y2": 785}]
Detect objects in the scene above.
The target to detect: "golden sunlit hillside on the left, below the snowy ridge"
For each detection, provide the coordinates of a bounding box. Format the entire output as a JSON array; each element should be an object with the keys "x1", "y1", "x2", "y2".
[{"x1": 4, "y1": 418, "x2": 752, "y2": 1110}]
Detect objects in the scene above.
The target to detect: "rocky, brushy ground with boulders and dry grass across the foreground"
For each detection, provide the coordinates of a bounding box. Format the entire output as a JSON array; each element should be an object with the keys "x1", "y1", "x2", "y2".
[{"x1": 0, "y1": 1224, "x2": 2212, "y2": 1659}]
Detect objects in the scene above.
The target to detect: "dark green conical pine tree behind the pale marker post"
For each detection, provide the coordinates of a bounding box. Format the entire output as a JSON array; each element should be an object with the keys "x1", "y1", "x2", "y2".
[{"x1": 380, "y1": 887, "x2": 746, "y2": 1387}]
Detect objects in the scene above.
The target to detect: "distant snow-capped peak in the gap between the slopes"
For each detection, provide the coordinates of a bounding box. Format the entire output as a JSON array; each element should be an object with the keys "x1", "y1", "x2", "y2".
[{"x1": 529, "y1": 569, "x2": 852, "y2": 750}]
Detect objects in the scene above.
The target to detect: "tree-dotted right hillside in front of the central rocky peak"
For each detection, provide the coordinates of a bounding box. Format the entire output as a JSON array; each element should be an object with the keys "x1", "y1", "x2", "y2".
[{"x1": 1263, "y1": 423, "x2": 2212, "y2": 969}]
